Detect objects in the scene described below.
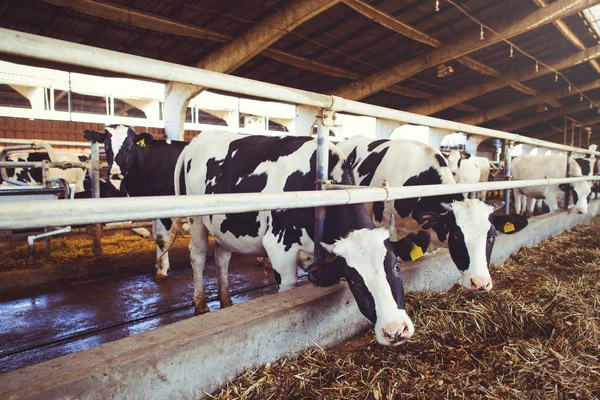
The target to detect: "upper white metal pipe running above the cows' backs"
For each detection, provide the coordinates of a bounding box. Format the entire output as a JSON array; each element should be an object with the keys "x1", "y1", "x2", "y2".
[{"x1": 0, "y1": 28, "x2": 600, "y2": 155}]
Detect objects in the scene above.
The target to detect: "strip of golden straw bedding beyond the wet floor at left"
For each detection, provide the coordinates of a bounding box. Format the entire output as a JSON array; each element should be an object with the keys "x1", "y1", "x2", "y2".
[{"x1": 0, "y1": 233, "x2": 190, "y2": 271}]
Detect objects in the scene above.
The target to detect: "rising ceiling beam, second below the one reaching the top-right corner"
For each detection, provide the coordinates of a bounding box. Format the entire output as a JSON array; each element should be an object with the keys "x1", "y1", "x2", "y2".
[{"x1": 458, "y1": 79, "x2": 600, "y2": 125}]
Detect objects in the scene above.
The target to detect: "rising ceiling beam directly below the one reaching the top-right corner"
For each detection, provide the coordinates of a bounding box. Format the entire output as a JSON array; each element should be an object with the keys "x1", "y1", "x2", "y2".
[{"x1": 407, "y1": 46, "x2": 600, "y2": 115}]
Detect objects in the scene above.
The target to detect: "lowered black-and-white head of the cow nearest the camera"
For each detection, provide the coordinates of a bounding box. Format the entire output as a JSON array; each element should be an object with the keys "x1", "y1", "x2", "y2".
[{"x1": 307, "y1": 218, "x2": 415, "y2": 346}]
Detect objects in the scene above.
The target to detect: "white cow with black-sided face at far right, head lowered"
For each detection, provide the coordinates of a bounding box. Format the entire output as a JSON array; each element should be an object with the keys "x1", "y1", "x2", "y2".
[{"x1": 512, "y1": 154, "x2": 591, "y2": 215}]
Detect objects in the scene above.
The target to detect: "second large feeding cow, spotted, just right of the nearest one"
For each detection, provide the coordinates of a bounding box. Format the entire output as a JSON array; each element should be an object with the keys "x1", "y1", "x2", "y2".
[{"x1": 338, "y1": 136, "x2": 524, "y2": 291}]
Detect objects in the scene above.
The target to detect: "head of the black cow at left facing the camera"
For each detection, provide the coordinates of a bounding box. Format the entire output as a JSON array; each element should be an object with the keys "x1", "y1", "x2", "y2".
[{"x1": 83, "y1": 125, "x2": 153, "y2": 189}]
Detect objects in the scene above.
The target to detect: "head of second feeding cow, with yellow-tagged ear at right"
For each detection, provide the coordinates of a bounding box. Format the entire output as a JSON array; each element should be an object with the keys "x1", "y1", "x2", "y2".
[{"x1": 417, "y1": 199, "x2": 524, "y2": 291}]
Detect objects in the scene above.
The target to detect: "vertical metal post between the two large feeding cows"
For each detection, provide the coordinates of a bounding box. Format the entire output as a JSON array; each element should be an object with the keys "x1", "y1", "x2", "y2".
[{"x1": 315, "y1": 111, "x2": 329, "y2": 262}]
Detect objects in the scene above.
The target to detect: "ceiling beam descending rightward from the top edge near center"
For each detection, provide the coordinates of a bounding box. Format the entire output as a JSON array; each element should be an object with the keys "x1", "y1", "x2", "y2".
[{"x1": 343, "y1": 0, "x2": 548, "y2": 101}]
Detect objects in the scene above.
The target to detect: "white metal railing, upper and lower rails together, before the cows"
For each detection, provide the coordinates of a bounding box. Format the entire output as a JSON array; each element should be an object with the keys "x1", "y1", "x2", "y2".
[{"x1": 0, "y1": 29, "x2": 600, "y2": 229}]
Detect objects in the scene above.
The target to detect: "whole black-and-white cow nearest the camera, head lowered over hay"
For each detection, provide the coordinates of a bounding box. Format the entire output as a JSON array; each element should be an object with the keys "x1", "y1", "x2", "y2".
[{"x1": 175, "y1": 131, "x2": 414, "y2": 345}]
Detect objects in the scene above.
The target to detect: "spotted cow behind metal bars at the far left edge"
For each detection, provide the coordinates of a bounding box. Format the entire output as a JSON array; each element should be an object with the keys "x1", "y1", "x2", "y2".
[{"x1": 0, "y1": 151, "x2": 87, "y2": 193}]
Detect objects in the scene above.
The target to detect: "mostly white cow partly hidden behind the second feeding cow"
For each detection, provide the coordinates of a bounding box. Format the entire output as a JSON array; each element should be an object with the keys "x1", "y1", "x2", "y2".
[{"x1": 448, "y1": 150, "x2": 490, "y2": 200}]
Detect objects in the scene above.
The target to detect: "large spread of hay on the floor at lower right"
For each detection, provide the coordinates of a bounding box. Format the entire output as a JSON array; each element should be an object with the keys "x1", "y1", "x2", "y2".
[{"x1": 209, "y1": 219, "x2": 600, "y2": 400}]
